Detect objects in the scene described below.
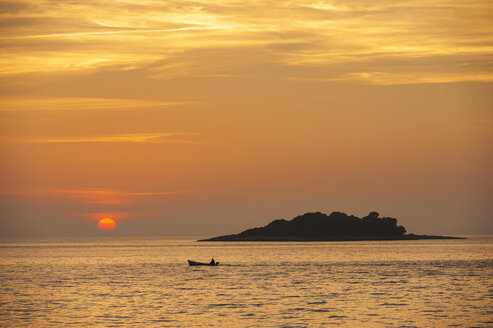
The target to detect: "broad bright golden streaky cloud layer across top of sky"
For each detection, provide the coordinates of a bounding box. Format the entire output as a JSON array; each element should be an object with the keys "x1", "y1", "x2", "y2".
[{"x1": 0, "y1": 0, "x2": 493, "y2": 84}]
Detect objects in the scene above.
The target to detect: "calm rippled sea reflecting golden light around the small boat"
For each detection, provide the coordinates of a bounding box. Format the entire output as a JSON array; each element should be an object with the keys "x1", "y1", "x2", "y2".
[{"x1": 0, "y1": 237, "x2": 493, "y2": 327}]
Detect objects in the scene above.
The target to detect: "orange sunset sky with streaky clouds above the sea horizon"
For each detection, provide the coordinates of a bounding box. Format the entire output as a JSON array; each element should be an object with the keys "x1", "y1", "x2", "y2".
[{"x1": 0, "y1": 0, "x2": 493, "y2": 237}]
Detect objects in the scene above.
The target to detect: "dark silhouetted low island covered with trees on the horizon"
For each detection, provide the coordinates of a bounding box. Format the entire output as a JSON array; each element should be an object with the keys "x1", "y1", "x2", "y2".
[{"x1": 199, "y1": 212, "x2": 464, "y2": 241}]
